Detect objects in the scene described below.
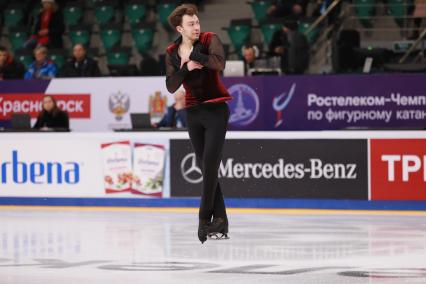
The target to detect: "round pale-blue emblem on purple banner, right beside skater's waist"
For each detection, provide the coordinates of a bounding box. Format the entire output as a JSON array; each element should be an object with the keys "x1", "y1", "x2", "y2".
[{"x1": 228, "y1": 84, "x2": 260, "y2": 126}]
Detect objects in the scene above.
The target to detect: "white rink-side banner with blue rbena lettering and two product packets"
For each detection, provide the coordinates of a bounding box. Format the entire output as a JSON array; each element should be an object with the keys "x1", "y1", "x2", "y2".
[{"x1": 0, "y1": 133, "x2": 169, "y2": 198}]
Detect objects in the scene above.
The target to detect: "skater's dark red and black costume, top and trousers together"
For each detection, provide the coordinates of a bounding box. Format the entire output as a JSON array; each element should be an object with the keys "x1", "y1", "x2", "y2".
[{"x1": 166, "y1": 32, "x2": 232, "y2": 221}]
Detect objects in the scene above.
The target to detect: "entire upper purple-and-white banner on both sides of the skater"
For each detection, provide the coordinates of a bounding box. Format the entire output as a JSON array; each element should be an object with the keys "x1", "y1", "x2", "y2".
[{"x1": 0, "y1": 74, "x2": 426, "y2": 132}]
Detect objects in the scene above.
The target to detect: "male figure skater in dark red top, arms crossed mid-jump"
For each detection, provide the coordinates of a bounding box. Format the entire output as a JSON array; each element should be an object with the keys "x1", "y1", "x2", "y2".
[{"x1": 166, "y1": 4, "x2": 232, "y2": 243}]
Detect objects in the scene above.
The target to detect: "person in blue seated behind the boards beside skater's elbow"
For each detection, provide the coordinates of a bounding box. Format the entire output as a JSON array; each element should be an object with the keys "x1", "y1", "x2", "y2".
[{"x1": 153, "y1": 90, "x2": 186, "y2": 128}]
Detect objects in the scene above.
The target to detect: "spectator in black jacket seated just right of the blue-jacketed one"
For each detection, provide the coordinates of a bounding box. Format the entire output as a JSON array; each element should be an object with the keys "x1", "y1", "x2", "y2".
[{"x1": 61, "y1": 44, "x2": 101, "y2": 77}]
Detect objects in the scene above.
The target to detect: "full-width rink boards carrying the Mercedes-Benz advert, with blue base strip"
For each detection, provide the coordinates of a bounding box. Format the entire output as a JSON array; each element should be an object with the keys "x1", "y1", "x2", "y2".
[{"x1": 0, "y1": 131, "x2": 426, "y2": 210}]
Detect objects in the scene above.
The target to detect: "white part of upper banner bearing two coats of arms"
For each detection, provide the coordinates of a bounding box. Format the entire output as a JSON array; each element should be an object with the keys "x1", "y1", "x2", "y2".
[{"x1": 46, "y1": 77, "x2": 173, "y2": 131}]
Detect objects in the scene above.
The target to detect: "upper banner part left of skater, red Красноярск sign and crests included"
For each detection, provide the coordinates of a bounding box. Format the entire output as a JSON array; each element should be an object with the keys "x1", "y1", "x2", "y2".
[{"x1": 0, "y1": 77, "x2": 173, "y2": 132}]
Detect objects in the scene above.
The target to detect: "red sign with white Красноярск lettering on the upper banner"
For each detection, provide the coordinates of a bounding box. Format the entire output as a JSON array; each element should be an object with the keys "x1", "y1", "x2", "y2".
[{"x1": 0, "y1": 93, "x2": 90, "y2": 120}]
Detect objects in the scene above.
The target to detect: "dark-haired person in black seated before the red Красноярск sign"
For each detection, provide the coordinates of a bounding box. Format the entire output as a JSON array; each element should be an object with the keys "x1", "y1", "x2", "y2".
[{"x1": 34, "y1": 95, "x2": 69, "y2": 130}]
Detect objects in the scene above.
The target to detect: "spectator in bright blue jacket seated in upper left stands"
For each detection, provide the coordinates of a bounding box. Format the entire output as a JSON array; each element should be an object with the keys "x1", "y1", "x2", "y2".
[{"x1": 24, "y1": 46, "x2": 57, "y2": 80}]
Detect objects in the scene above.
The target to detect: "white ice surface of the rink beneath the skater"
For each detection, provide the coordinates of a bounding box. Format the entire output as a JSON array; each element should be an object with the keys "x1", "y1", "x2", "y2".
[{"x1": 0, "y1": 207, "x2": 426, "y2": 284}]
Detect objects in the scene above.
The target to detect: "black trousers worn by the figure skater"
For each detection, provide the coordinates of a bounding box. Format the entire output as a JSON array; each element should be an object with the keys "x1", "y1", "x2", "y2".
[{"x1": 187, "y1": 103, "x2": 229, "y2": 220}]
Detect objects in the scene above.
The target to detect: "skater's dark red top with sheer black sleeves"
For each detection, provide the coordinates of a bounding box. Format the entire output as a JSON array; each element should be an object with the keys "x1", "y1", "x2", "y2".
[{"x1": 166, "y1": 32, "x2": 232, "y2": 107}]
